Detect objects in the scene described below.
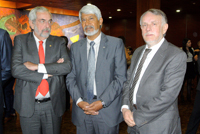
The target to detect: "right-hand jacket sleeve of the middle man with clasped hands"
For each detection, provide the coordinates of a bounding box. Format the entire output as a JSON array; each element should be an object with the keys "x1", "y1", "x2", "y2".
[{"x1": 99, "y1": 40, "x2": 126, "y2": 106}]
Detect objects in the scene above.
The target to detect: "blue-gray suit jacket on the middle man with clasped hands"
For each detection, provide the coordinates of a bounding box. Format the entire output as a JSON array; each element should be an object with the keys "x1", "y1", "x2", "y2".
[{"x1": 66, "y1": 33, "x2": 126, "y2": 127}]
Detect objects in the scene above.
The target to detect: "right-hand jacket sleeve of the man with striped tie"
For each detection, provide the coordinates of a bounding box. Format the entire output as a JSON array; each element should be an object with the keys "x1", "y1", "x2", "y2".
[{"x1": 133, "y1": 52, "x2": 187, "y2": 127}]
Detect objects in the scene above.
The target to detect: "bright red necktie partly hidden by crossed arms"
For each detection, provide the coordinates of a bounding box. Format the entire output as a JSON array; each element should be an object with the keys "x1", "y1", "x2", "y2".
[{"x1": 35, "y1": 41, "x2": 49, "y2": 96}]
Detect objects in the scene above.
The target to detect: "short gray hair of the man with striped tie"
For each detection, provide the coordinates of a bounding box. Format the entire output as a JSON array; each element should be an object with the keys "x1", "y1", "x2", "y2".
[{"x1": 140, "y1": 9, "x2": 167, "y2": 25}]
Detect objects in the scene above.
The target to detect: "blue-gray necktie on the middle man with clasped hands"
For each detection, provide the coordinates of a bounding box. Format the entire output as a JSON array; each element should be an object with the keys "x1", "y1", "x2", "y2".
[{"x1": 87, "y1": 41, "x2": 95, "y2": 101}]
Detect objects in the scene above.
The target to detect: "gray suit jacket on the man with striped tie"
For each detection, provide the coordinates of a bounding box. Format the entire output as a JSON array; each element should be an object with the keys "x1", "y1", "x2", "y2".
[{"x1": 122, "y1": 40, "x2": 187, "y2": 134}]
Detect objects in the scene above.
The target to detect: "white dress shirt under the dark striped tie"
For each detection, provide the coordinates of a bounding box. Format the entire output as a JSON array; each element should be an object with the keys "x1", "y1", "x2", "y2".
[{"x1": 121, "y1": 38, "x2": 165, "y2": 110}]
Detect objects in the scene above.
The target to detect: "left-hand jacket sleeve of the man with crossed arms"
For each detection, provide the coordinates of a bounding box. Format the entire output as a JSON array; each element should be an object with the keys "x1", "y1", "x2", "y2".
[{"x1": 12, "y1": 36, "x2": 43, "y2": 83}]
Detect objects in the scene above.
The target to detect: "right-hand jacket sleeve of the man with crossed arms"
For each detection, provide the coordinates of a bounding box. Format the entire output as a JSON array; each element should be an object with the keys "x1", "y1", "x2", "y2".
[{"x1": 44, "y1": 39, "x2": 72, "y2": 75}]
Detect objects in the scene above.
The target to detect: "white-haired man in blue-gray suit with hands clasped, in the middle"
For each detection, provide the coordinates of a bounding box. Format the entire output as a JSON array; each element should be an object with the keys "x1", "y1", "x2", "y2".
[{"x1": 66, "y1": 5, "x2": 126, "y2": 134}]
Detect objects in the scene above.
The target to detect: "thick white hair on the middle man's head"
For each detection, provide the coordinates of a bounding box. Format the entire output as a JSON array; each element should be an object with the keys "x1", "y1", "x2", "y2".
[{"x1": 79, "y1": 5, "x2": 102, "y2": 22}]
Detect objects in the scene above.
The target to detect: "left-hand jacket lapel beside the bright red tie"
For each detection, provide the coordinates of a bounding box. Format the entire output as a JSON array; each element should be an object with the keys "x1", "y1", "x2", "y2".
[{"x1": 27, "y1": 32, "x2": 39, "y2": 64}]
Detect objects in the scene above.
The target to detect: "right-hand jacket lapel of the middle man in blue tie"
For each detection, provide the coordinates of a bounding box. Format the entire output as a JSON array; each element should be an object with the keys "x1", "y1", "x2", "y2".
[{"x1": 96, "y1": 33, "x2": 108, "y2": 72}]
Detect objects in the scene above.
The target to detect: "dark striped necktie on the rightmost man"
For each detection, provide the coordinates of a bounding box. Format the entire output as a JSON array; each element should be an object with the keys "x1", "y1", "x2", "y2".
[{"x1": 129, "y1": 49, "x2": 151, "y2": 111}]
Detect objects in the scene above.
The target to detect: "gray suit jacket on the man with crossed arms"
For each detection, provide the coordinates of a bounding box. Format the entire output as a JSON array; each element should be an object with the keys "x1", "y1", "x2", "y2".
[{"x1": 12, "y1": 32, "x2": 71, "y2": 117}]
